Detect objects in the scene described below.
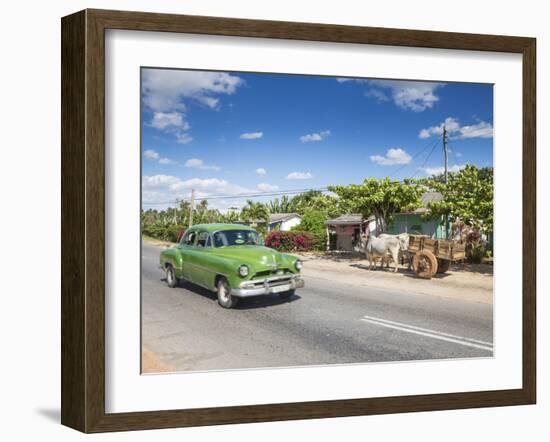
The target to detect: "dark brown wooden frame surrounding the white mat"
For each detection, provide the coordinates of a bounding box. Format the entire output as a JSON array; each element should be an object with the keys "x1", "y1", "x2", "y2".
[{"x1": 61, "y1": 10, "x2": 536, "y2": 432}]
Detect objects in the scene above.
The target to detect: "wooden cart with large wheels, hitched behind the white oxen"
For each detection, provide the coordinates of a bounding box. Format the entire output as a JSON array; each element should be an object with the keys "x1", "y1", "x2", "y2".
[{"x1": 408, "y1": 235, "x2": 466, "y2": 279}]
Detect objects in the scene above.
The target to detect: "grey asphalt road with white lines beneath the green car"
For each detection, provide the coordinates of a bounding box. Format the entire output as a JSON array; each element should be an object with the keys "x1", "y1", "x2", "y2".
[{"x1": 142, "y1": 244, "x2": 493, "y2": 371}]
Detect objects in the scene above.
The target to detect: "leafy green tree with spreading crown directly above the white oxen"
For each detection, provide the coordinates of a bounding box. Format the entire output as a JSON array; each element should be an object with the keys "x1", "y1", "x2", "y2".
[{"x1": 329, "y1": 178, "x2": 423, "y2": 231}]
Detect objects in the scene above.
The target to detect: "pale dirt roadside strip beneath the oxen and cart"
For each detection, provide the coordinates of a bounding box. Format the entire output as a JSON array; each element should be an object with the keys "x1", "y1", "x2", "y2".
[{"x1": 300, "y1": 254, "x2": 493, "y2": 304}]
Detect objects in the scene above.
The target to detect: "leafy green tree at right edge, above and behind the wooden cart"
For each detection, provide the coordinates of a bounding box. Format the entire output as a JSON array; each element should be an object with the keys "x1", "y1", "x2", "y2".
[{"x1": 422, "y1": 164, "x2": 493, "y2": 233}]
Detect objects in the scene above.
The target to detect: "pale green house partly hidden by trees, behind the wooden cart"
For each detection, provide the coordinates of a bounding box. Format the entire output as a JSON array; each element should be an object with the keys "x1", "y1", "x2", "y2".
[{"x1": 388, "y1": 192, "x2": 451, "y2": 239}]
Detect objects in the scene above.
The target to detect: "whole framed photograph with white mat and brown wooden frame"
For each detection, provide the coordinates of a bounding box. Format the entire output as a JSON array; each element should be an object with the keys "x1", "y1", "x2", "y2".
[{"x1": 61, "y1": 10, "x2": 536, "y2": 432}]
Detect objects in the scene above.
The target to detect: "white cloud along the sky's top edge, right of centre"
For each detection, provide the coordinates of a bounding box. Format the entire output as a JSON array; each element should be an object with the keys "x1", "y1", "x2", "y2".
[{"x1": 337, "y1": 78, "x2": 444, "y2": 112}]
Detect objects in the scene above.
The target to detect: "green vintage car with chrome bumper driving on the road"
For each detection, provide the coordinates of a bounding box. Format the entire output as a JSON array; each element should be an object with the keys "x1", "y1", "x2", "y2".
[{"x1": 160, "y1": 224, "x2": 304, "y2": 308}]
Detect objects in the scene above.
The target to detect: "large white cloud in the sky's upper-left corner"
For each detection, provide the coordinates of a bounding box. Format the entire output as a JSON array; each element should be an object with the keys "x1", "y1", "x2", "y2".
[{"x1": 142, "y1": 69, "x2": 244, "y2": 112}]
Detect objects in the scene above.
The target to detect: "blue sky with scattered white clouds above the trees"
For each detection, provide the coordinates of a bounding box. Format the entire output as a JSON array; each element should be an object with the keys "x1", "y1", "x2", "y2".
[{"x1": 141, "y1": 68, "x2": 493, "y2": 210}]
